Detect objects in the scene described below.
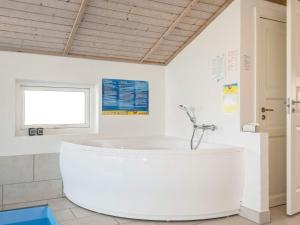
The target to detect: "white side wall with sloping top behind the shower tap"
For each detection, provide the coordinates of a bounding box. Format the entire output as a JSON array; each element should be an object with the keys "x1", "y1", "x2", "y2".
[{"x1": 166, "y1": 0, "x2": 240, "y2": 144}]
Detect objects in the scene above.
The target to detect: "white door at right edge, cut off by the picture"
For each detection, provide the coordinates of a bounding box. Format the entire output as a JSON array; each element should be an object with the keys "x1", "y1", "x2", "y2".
[{"x1": 287, "y1": 0, "x2": 300, "y2": 215}]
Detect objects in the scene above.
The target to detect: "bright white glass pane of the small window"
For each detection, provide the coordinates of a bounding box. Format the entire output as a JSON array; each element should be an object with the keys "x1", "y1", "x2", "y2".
[{"x1": 24, "y1": 90, "x2": 86, "y2": 125}]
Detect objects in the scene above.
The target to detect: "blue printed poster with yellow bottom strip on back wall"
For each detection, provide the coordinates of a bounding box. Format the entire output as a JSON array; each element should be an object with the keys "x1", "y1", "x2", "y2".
[{"x1": 102, "y1": 79, "x2": 149, "y2": 115}]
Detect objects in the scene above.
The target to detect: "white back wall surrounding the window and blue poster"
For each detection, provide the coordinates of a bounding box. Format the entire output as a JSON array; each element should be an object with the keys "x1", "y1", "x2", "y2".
[{"x1": 0, "y1": 52, "x2": 165, "y2": 155}]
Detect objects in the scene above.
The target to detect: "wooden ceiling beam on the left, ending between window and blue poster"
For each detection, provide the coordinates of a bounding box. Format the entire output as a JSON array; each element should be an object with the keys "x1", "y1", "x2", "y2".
[{"x1": 63, "y1": 0, "x2": 89, "y2": 55}]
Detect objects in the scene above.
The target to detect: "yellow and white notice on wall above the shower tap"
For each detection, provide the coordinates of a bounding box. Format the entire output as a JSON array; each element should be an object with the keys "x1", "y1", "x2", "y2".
[{"x1": 223, "y1": 83, "x2": 239, "y2": 113}]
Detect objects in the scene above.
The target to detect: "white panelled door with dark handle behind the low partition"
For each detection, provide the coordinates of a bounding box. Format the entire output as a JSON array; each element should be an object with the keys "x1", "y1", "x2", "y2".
[{"x1": 256, "y1": 17, "x2": 286, "y2": 207}]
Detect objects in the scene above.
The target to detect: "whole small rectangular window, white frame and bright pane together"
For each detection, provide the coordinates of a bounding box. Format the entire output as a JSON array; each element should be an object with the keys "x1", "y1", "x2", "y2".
[{"x1": 17, "y1": 82, "x2": 91, "y2": 134}]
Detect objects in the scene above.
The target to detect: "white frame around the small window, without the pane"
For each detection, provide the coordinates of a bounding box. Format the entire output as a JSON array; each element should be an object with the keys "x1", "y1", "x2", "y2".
[{"x1": 16, "y1": 81, "x2": 95, "y2": 135}]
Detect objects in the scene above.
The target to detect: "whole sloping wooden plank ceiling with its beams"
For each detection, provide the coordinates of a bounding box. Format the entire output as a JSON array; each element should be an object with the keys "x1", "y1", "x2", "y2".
[{"x1": 0, "y1": 0, "x2": 284, "y2": 64}]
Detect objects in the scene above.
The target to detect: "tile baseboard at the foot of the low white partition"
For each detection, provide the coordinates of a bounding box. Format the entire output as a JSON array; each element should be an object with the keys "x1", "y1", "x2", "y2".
[{"x1": 239, "y1": 206, "x2": 271, "y2": 224}]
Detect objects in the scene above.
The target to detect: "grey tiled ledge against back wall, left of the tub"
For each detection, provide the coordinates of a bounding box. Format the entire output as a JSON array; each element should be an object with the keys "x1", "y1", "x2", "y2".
[{"x1": 0, "y1": 153, "x2": 63, "y2": 208}]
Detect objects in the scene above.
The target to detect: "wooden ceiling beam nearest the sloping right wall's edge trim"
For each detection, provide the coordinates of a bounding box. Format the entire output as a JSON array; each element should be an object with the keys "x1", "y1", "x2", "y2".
[{"x1": 141, "y1": 0, "x2": 199, "y2": 62}]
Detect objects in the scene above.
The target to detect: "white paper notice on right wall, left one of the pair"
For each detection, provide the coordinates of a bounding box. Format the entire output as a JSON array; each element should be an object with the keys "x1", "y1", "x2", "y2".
[{"x1": 212, "y1": 54, "x2": 226, "y2": 82}]
